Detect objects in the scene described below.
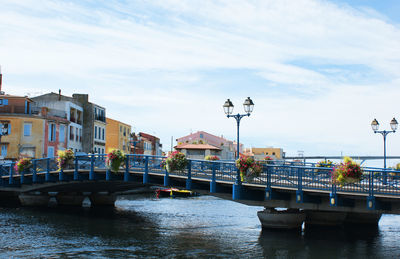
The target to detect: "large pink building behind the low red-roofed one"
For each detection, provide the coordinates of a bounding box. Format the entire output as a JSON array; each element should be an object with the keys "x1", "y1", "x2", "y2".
[{"x1": 176, "y1": 131, "x2": 243, "y2": 160}]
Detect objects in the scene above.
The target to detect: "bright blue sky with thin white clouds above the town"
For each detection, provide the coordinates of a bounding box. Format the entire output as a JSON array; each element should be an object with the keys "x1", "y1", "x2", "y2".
[{"x1": 0, "y1": 0, "x2": 400, "y2": 165}]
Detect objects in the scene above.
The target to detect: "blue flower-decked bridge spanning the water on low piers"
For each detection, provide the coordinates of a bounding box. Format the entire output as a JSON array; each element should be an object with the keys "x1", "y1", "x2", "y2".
[{"x1": 0, "y1": 154, "x2": 400, "y2": 229}]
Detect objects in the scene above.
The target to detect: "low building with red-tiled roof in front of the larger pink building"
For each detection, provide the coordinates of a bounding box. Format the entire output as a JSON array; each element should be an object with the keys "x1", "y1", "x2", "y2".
[{"x1": 174, "y1": 143, "x2": 222, "y2": 159}]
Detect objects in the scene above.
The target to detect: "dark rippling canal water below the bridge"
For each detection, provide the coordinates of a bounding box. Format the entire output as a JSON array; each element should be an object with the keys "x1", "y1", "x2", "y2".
[{"x1": 0, "y1": 196, "x2": 400, "y2": 258}]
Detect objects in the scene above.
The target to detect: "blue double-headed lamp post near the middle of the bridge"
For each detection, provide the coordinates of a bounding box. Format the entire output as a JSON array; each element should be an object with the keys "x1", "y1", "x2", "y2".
[{"x1": 223, "y1": 97, "x2": 254, "y2": 200}]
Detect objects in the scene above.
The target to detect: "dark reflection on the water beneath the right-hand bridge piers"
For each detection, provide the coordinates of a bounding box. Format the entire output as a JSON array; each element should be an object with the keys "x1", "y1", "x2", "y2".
[{"x1": 259, "y1": 226, "x2": 382, "y2": 258}]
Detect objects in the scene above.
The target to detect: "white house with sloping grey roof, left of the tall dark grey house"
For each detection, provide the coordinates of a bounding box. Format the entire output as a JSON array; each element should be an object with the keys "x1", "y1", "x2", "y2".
[{"x1": 31, "y1": 90, "x2": 84, "y2": 152}]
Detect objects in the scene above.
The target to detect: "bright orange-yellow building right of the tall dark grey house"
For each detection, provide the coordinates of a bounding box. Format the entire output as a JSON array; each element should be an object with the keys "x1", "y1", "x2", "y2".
[{"x1": 106, "y1": 118, "x2": 131, "y2": 154}]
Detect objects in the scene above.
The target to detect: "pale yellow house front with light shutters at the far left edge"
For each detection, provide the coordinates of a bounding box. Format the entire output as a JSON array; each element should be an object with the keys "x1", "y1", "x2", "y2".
[{"x1": 0, "y1": 114, "x2": 45, "y2": 160}]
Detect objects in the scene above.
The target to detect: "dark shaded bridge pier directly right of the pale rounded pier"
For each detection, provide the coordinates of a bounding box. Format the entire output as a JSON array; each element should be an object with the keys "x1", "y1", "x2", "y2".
[{"x1": 305, "y1": 210, "x2": 347, "y2": 226}]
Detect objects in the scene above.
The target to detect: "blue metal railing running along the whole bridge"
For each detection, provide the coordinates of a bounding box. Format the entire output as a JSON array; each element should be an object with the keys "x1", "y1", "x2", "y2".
[{"x1": 0, "y1": 154, "x2": 400, "y2": 205}]
